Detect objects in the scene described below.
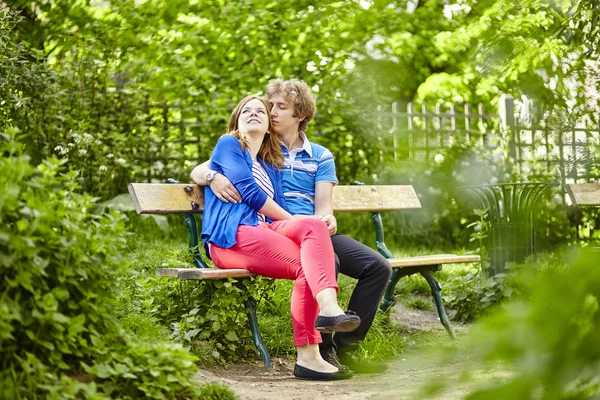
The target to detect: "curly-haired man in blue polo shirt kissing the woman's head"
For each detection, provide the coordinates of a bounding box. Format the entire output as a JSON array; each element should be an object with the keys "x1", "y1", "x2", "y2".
[{"x1": 190, "y1": 79, "x2": 392, "y2": 373}]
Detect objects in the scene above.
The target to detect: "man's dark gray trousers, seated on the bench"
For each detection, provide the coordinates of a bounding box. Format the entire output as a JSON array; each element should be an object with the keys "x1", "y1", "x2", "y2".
[{"x1": 320, "y1": 234, "x2": 392, "y2": 351}]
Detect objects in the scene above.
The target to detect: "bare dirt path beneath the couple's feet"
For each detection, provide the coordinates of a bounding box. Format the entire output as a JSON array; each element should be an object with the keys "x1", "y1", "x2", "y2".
[{"x1": 193, "y1": 304, "x2": 508, "y2": 400}]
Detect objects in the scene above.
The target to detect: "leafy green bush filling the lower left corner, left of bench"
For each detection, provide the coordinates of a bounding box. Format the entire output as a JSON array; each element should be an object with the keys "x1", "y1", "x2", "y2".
[{"x1": 0, "y1": 134, "x2": 209, "y2": 399}]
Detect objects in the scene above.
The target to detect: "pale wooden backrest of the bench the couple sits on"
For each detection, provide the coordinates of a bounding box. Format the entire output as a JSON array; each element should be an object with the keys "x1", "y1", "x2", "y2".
[{"x1": 128, "y1": 183, "x2": 421, "y2": 214}]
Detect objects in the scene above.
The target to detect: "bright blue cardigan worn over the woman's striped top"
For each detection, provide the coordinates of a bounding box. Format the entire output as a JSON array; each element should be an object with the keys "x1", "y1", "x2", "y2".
[{"x1": 202, "y1": 135, "x2": 287, "y2": 253}]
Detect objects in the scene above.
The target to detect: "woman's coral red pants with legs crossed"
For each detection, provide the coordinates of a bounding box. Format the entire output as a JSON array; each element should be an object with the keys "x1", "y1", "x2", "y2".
[{"x1": 210, "y1": 218, "x2": 338, "y2": 346}]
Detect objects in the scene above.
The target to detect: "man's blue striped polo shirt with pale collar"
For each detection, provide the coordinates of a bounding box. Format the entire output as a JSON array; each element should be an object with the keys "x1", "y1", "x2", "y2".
[{"x1": 281, "y1": 132, "x2": 338, "y2": 215}]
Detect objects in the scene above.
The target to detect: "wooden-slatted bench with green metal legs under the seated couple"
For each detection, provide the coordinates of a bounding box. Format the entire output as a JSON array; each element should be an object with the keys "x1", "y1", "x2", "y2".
[{"x1": 128, "y1": 181, "x2": 481, "y2": 370}]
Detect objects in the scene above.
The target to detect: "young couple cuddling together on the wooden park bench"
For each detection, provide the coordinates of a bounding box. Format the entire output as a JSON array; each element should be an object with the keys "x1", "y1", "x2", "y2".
[{"x1": 191, "y1": 79, "x2": 391, "y2": 380}]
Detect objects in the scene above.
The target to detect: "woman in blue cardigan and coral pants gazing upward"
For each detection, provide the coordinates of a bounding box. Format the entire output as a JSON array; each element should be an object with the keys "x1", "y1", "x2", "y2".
[{"x1": 199, "y1": 96, "x2": 360, "y2": 380}]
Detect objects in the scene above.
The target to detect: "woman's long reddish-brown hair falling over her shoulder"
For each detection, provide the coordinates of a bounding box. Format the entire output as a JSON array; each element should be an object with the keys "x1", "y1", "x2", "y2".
[{"x1": 227, "y1": 95, "x2": 283, "y2": 168}]
